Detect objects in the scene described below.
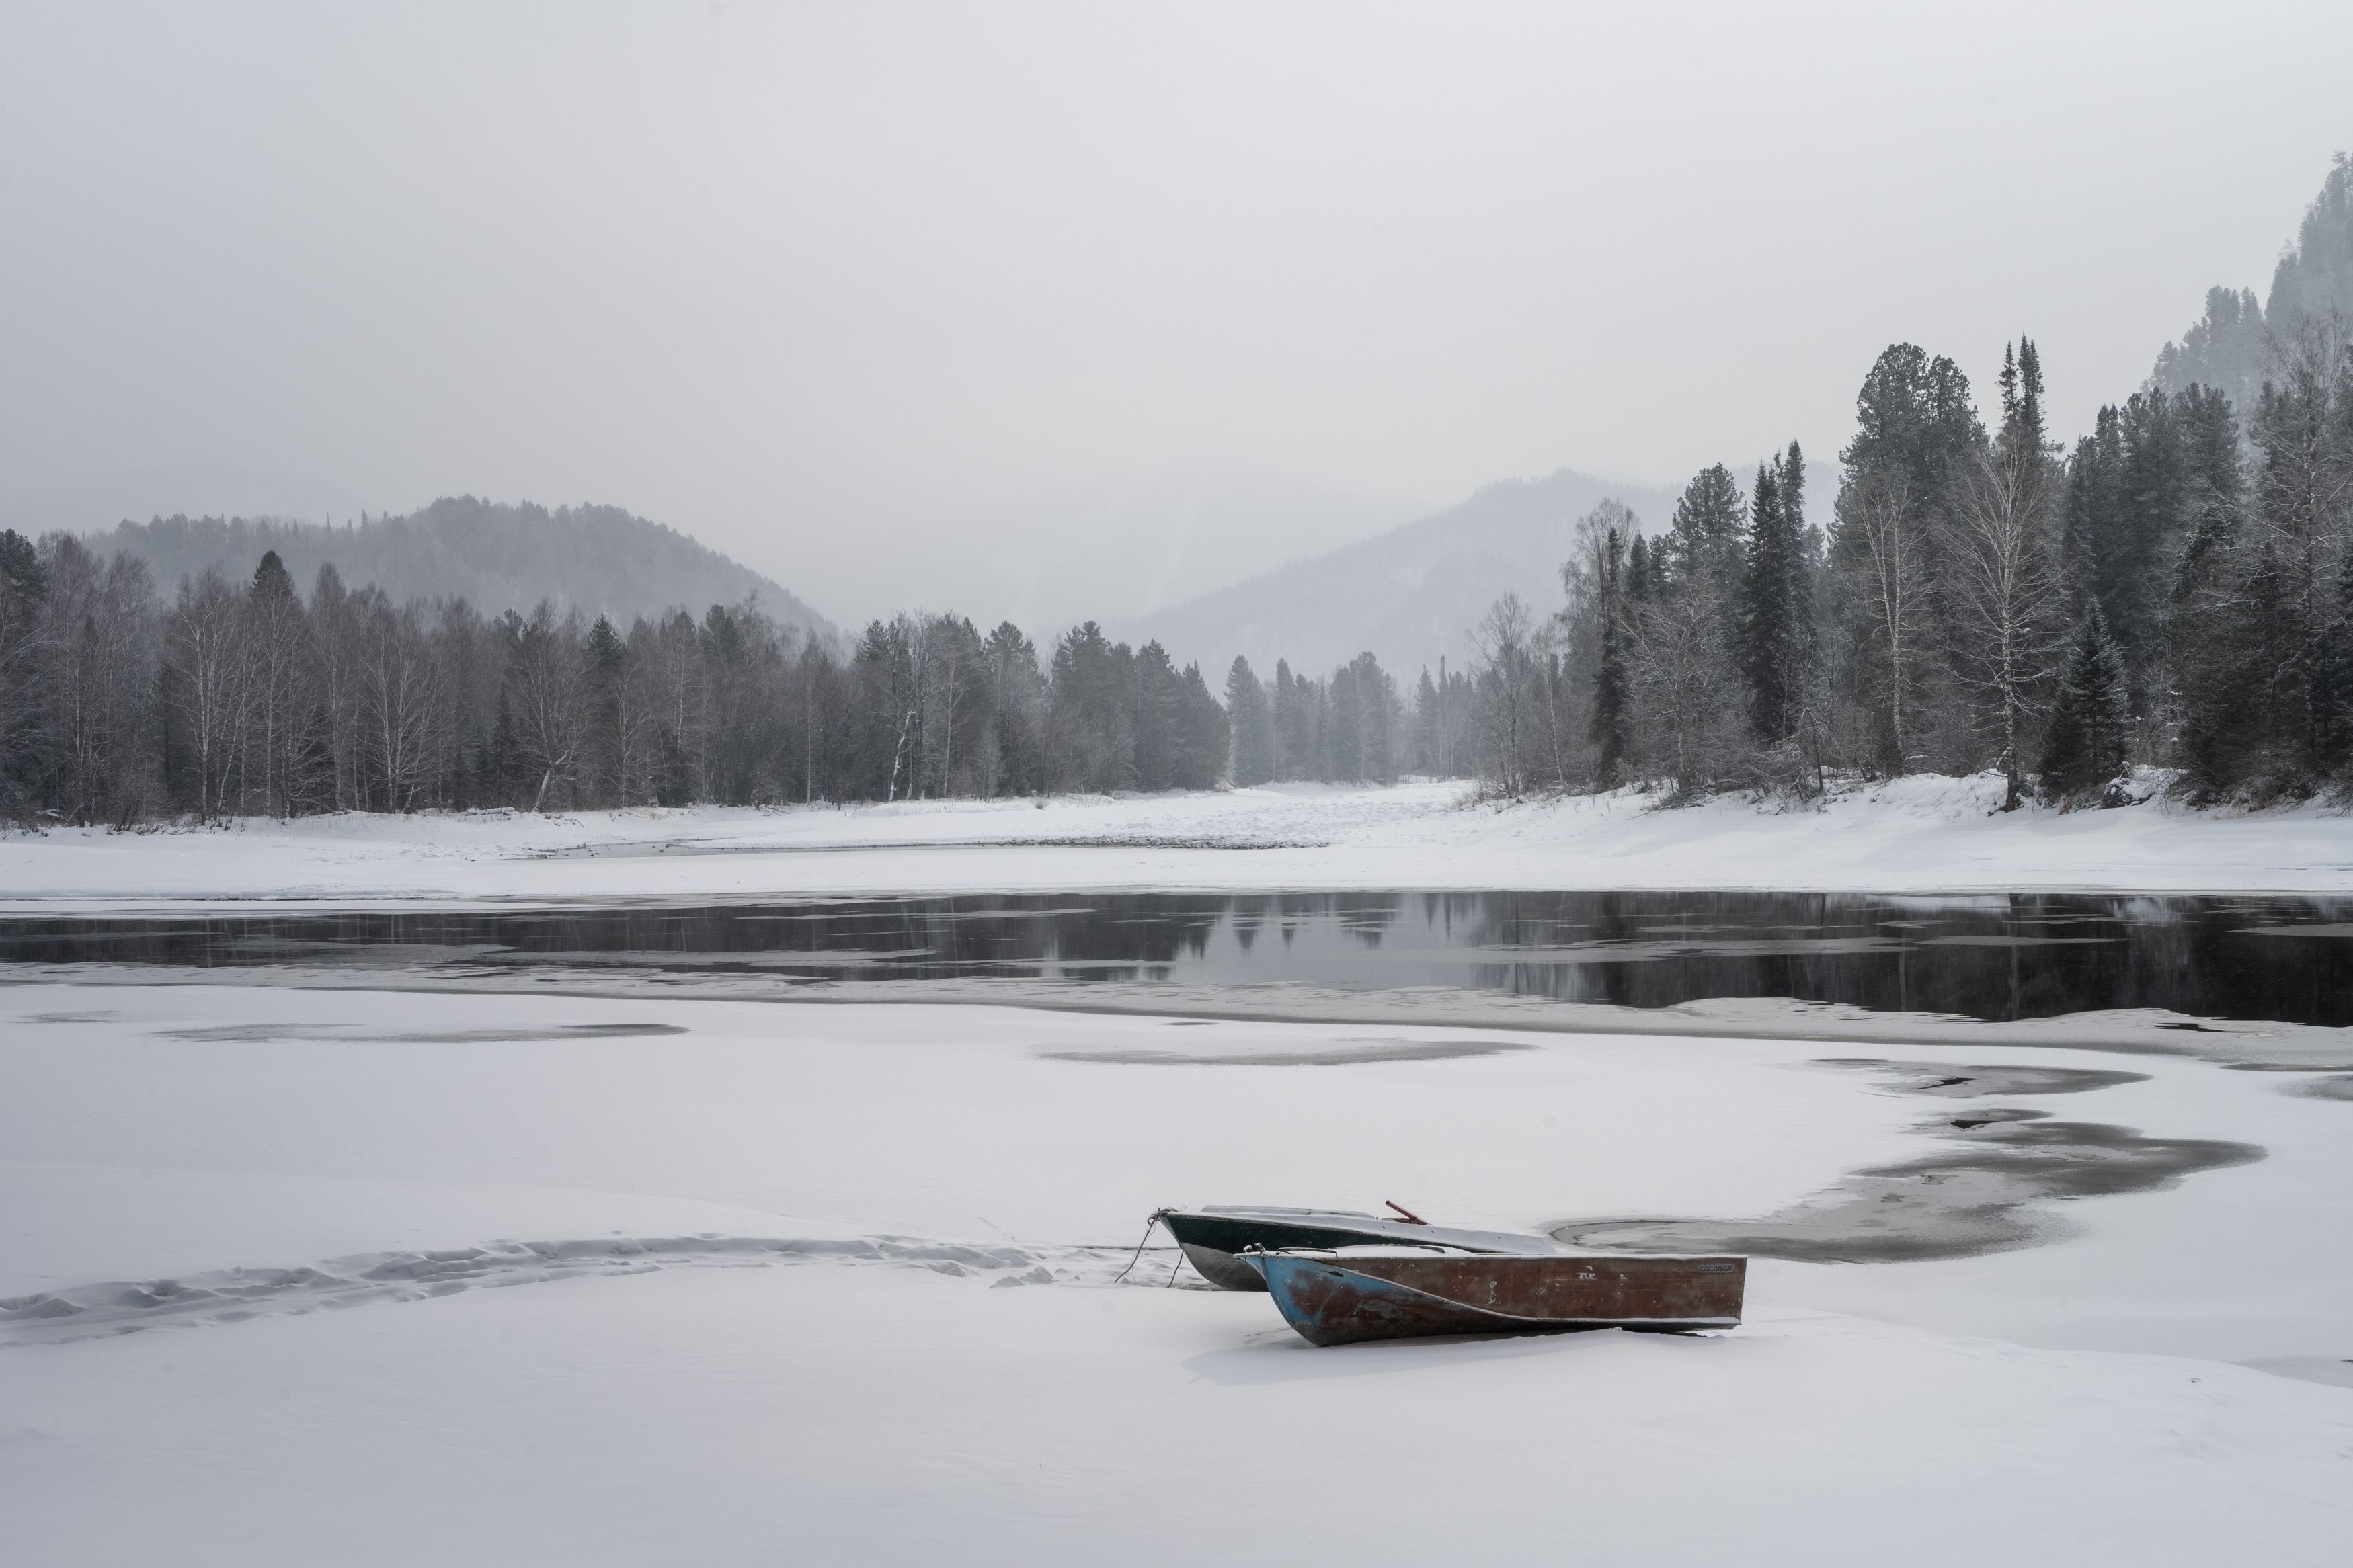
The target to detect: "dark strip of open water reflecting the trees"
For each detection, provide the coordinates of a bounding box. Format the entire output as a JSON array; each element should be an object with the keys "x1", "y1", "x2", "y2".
[{"x1": 0, "y1": 891, "x2": 2353, "y2": 1025}]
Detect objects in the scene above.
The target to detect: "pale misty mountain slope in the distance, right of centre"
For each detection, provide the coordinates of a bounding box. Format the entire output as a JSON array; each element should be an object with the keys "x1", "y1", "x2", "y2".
[{"x1": 1120, "y1": 468, "x2": 1673, "y2": 684}]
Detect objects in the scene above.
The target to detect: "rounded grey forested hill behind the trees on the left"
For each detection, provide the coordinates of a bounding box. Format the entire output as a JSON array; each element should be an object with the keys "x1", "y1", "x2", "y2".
[{"x1": 89, "y1": 496, "x2": 836, "y2": 637}]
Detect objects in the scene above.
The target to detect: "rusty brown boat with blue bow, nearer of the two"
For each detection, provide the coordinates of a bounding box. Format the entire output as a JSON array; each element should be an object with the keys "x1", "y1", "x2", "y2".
[{"x1": 1240, "y1": 1246, "x2": 1749, "y2": 1345}]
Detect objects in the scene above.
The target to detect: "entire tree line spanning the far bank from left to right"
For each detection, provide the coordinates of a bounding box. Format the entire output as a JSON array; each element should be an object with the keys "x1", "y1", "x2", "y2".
[{"x1": 0, "y1": 313, "x2": 2353, "y2": 825}]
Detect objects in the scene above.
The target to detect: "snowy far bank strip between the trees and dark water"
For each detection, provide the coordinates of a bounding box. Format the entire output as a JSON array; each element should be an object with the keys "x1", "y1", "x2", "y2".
[{"x1": 0, "y1": 776, "x2": 2353, "y2": 912}]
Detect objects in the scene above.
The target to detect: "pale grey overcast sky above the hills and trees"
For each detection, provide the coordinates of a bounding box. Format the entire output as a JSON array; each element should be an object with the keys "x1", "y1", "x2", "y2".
[{"x1": 0, "y1": 0, "x2": 2353, "y2": 618}]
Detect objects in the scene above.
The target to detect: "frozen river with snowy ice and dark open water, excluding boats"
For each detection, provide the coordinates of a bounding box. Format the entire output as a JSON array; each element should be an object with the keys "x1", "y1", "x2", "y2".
[{"x1": 0, "y1": 860, "x2": 2353, "y2": 1568}]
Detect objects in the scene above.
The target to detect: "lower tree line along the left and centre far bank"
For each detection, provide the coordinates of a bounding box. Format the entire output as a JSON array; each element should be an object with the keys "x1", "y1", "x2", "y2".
[{"x1": 0, "y1": 531, "x2": 1431, "y2": 825}]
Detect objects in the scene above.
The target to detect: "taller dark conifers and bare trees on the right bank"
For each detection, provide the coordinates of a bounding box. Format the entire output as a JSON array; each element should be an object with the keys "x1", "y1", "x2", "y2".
[{"x1": 1476, "y1": 315, "x2": 2353, "y2": 809}]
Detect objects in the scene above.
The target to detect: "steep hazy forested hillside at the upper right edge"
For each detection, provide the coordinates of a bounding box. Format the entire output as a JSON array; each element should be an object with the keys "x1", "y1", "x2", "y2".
[{"x1": 2149, "y1": 153, "x2": 2353, "y2": 411}]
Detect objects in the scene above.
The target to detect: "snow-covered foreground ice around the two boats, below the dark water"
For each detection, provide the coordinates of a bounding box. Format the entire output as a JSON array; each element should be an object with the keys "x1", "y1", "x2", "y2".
[{"x1": 0, "y1": 985, "x2": 2353, "y2": 1566}]
